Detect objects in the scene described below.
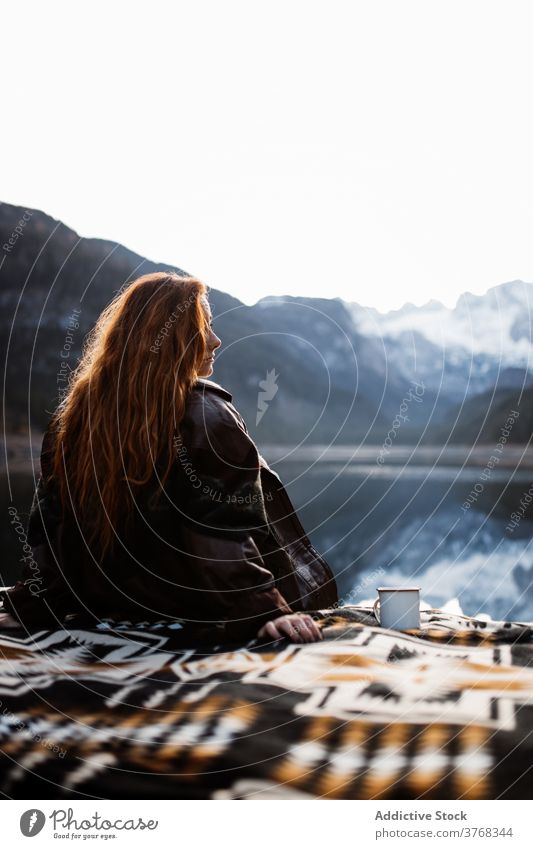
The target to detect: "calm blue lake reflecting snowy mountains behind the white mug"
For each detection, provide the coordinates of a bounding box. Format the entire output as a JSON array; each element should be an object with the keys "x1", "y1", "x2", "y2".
[{"x1": 0, "y1": 445, "x2": 533, "y2": 620}]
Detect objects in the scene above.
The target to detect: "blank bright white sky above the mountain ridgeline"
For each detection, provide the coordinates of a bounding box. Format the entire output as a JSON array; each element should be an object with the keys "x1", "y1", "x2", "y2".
[{"x1": 0, "y1": 0, "x2": 533, "y2": 310}]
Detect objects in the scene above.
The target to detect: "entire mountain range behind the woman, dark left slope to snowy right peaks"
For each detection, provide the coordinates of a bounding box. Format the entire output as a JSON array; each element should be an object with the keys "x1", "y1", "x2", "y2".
[{"x1": 0, "y1": 203, "x2": 533, "y2": 445}]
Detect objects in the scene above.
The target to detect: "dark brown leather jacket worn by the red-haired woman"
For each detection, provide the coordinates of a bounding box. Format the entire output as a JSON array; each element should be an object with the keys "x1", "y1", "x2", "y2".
[{"x1": 3, "y1": 378, "x2": 337, "y2": 640}]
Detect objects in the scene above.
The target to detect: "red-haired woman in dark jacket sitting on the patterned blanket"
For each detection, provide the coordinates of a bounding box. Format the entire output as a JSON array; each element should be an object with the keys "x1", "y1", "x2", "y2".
[{"x1": 3, "y1": 273, "x2": 337, "y2": 642}]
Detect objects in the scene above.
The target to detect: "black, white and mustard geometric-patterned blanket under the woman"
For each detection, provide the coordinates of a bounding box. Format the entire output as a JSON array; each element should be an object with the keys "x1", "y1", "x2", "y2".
[{"x1": 0, "y1": 606, "x2": 533, "y2": 799}]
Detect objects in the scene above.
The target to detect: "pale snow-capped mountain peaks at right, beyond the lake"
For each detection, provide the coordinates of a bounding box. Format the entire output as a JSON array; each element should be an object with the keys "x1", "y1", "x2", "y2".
[{"x1": 347, "y1": 280, "x2": 533, "y2": 443}]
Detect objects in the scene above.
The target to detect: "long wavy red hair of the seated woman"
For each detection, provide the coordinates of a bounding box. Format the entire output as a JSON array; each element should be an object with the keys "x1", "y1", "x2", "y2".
[{"x1": 51, "y1": 272, "x2": 209, "y2": 558}]
